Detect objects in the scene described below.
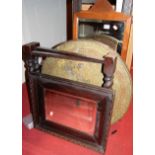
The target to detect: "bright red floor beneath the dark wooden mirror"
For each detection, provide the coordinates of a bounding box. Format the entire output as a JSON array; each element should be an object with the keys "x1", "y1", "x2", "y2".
[{"x1": 22, "y1": 84, "x2": 133, "y2": 155}]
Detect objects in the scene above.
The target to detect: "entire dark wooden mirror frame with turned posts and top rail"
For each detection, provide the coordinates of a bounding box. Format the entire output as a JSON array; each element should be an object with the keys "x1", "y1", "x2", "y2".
[{"x1": 22, "y1": 42, "x2": 116, "y2": 152}]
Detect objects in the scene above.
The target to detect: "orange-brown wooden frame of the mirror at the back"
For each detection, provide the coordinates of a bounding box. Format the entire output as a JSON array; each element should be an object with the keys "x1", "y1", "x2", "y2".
[{"x1": 73, "y1": 11, "x2": 131, "y2": 62}]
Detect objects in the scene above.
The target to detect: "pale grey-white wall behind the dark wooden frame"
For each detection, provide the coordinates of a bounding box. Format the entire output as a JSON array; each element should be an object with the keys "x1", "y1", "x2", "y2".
[{"x1": 22, "y1": 0, "x2": 66, "y2": 82}]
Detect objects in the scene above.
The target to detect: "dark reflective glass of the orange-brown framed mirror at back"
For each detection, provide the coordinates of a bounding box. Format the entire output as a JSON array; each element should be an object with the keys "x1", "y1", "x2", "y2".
[{"x1": 78, "y1": 19, "x2": 124, "y2": 54}]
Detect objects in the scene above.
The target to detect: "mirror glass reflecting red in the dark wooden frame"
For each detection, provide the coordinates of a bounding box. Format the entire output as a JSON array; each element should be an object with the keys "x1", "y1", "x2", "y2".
[{"x1": 44, "y1": 89, "x2": 97, "y2": 135}]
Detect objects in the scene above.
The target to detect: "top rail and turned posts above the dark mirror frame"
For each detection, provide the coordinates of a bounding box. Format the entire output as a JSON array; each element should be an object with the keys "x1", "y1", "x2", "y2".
[{"x1": 23, "y1": 42, "x2": 116, "y2": 88}]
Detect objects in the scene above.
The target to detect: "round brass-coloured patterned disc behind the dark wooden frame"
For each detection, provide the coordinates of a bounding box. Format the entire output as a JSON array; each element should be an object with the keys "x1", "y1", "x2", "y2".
[{"x1": 42, "y1": 39, "x2": 132, "y2": 124}]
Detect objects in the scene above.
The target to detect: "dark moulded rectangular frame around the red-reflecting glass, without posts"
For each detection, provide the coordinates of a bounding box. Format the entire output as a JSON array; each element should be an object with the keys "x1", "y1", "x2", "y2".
[{"x1": 30, "y1": 73, "x2": 113, "y2": 152}]
